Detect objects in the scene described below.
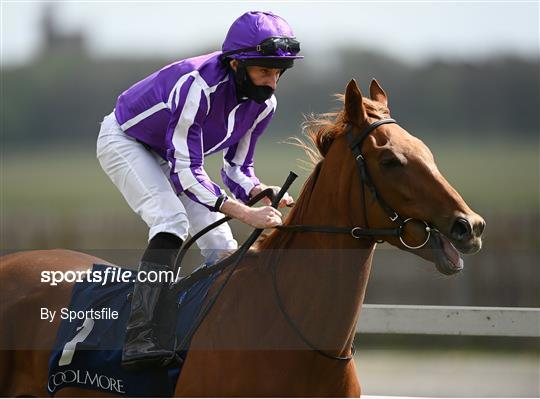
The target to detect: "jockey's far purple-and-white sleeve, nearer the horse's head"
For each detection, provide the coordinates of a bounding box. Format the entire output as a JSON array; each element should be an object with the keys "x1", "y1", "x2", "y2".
[{"x1": 221, "y1": 96, "x2": 277, "y2": 203}]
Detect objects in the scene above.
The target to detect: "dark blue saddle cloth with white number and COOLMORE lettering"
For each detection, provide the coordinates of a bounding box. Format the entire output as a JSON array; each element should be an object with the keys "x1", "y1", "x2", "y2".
[{"x1": 47, "y1": 264, "x2": 219, "y2": 397}]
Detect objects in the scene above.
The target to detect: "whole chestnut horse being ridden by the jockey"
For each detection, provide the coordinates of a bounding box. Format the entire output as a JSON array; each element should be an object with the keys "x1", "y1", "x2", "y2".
[{"x1": 0, "y1": 80, "x2": 485, "y2": 397}]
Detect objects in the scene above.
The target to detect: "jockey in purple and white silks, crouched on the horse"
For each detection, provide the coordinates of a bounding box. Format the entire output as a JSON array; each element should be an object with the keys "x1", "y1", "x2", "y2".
[{"x1": 97, "y1": 11, "x2": 303, "y2": 369}]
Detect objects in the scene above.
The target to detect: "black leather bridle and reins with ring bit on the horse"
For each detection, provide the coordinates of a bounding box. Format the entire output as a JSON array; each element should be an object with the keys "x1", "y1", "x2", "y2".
[{"x1": 170, "y1": 118, "x2": 432, "y2": 361}]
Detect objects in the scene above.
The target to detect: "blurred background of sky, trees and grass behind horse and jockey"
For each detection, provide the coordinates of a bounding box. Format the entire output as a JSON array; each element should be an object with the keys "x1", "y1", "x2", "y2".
[{"x1": 0, "y1": 1, "x2": 540, "y2": 396}]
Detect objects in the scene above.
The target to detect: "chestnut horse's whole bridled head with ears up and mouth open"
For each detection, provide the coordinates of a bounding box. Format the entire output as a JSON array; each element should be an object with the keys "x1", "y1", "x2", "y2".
[{"x1": 308, "y1": 80, "x2": 485, "y2": 274}]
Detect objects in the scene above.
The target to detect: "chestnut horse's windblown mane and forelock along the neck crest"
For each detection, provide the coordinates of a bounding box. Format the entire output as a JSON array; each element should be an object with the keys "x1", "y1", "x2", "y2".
[{"x1": 256, "y1": 94, "x2": 390, "y2": 250}]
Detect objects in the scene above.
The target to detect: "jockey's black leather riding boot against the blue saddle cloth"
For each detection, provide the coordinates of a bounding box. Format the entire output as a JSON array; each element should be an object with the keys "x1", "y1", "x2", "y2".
[{"x1": 122, "y1": 261, "x2": 177, "y2": 371}]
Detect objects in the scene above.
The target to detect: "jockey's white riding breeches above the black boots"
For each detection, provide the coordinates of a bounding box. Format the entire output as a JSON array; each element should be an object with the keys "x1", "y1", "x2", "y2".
[{"x1": 97, "y1": 112, "x2": 238, "y2": 258}]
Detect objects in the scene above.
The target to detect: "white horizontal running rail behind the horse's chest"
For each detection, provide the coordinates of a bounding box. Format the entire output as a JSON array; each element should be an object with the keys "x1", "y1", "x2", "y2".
[{"x1": 356, "y1": 304, "x2": 540, "y2": 337}]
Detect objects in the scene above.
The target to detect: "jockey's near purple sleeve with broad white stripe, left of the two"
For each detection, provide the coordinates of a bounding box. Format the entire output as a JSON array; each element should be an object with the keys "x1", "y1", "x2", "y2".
[{"x1": 167, "y1": 75, "x2": 226, "y2": 211}]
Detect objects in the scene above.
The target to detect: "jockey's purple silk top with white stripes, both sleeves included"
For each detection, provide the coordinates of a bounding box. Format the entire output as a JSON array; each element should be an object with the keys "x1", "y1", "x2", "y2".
[{"x1": 115, "y1": 52, "x2": 276, "y2": 210}]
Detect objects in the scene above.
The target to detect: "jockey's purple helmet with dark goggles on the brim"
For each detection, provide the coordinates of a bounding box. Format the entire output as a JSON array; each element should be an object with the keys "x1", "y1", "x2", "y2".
[{"x1": 222, "y1": 11, "x2": 304, "y2": 65}]
